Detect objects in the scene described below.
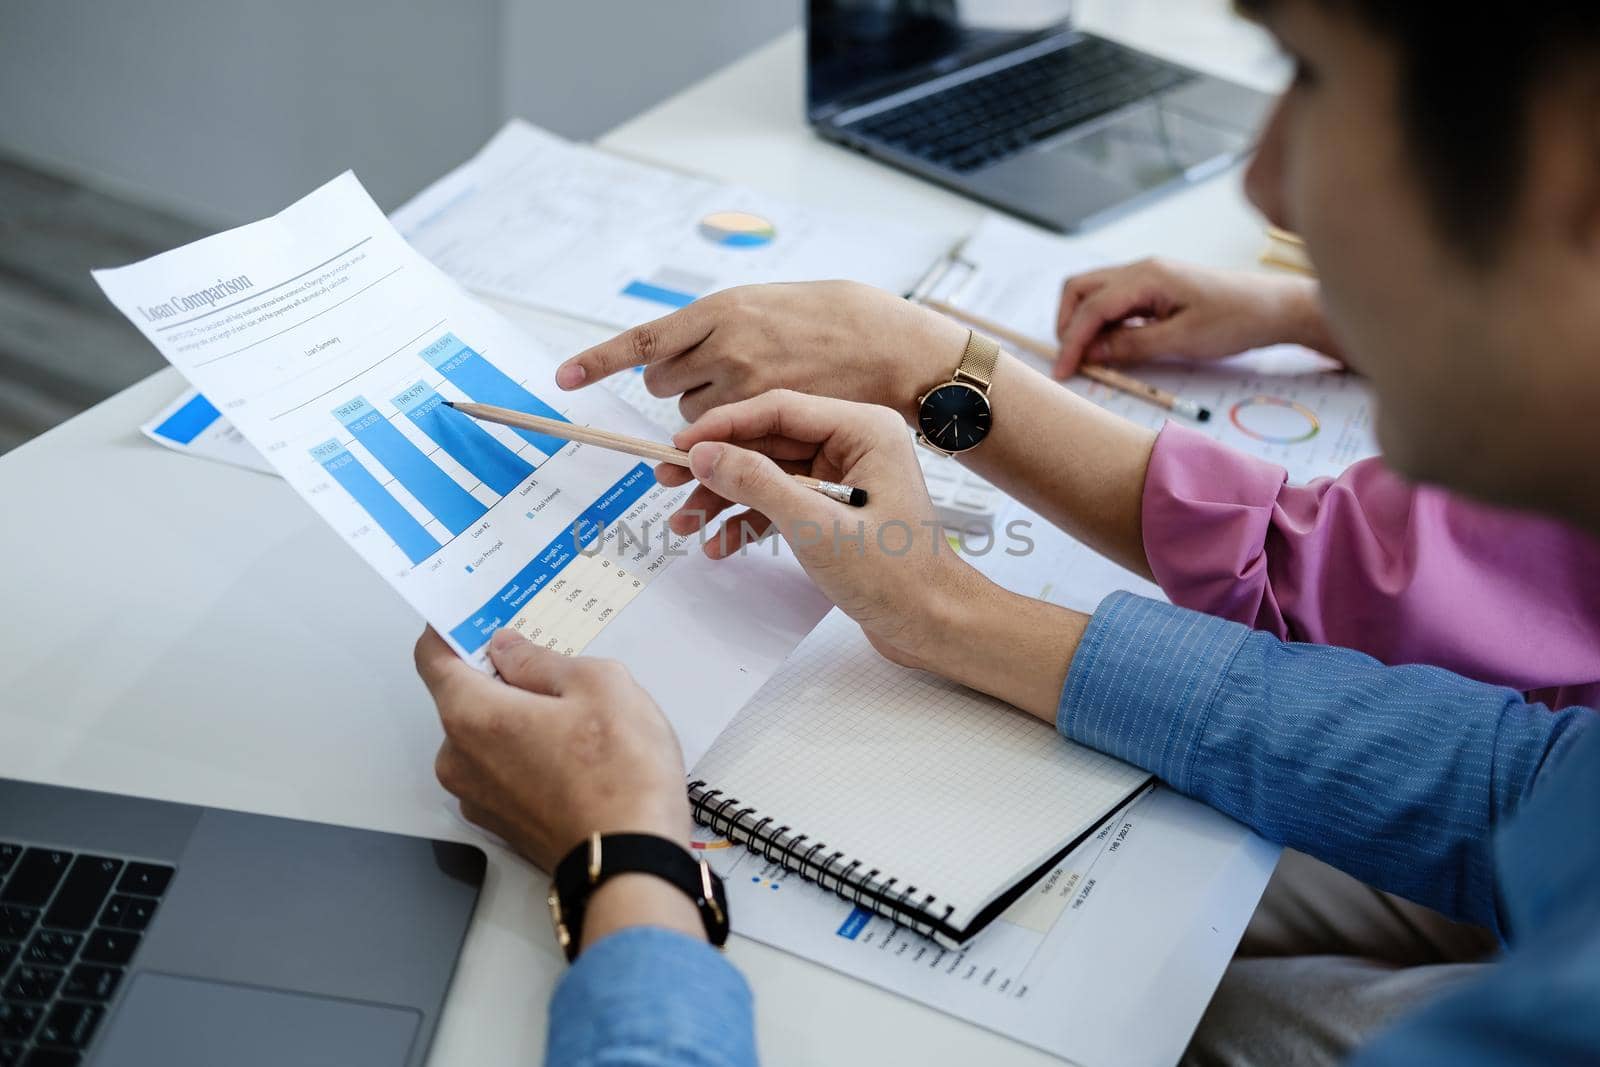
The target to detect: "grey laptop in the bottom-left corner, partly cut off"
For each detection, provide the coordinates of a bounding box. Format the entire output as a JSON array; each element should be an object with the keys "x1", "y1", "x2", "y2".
[{"x1": 0, "y1": 779, "x2": 485, "y2": 1067}]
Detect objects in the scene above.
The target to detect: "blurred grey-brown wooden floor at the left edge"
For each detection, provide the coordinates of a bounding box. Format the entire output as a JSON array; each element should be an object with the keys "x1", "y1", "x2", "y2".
[{"x1": 0, "y1": 157, "x2": 205, "y2": 453}]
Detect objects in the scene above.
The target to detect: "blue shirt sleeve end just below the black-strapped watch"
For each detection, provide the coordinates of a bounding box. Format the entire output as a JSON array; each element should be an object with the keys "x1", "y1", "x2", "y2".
[{"x1": 544, "y1": 926, "x2": 755, "y2": 1067}]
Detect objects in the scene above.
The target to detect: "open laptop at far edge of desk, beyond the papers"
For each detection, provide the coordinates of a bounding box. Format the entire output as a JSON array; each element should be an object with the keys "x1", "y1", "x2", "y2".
[{"x1": 806, "y1": 0, "x2": 1272, "y2": 232}]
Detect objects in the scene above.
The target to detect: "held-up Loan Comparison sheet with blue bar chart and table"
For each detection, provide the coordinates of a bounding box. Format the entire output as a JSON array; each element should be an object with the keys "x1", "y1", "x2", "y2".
[{"x1": 94, "y1": 173, "x2": 827, "y2": 761}]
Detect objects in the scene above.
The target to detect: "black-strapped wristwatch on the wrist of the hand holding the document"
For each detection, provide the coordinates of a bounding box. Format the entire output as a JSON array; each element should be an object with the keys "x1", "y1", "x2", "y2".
[{"x1": 547, "y1": 833, "x2": 728, "y2": 963}]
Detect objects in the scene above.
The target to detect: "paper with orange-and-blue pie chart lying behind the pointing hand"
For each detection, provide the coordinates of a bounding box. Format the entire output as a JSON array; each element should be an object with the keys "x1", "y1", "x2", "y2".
[{"x1": 394, "y1": 120, "x2": 949, "y2": 330}]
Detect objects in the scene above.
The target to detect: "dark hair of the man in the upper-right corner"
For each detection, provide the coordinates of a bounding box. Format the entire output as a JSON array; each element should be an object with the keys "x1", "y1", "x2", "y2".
[{"x1": 1235, "y1": 0, "x2": 1600, "y2": 261}]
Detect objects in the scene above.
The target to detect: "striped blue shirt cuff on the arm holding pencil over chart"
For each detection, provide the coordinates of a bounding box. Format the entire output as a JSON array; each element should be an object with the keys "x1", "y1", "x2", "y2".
[{"x1": 1056, "y1": 592, "x2": 1250, "y2": 792}]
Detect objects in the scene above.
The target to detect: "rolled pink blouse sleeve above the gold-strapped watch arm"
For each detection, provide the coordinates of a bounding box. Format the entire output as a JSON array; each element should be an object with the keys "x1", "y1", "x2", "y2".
[{"x1": 1144, "y1": 424, "x2": 1600, "y2": 707}]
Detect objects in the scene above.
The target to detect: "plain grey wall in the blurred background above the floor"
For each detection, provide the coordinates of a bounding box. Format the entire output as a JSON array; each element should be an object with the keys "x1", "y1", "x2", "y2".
[{"x1": 0, "y1": 0, "x2": 798, "y2": 224}]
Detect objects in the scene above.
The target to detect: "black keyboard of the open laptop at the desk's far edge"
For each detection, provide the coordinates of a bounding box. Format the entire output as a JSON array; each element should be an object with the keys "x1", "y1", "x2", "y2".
[{"x1": 850, "y1": 37, "x2": 1195, "y2": 171}]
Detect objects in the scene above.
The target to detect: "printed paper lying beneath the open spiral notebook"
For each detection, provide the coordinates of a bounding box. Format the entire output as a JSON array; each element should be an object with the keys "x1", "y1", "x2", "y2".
[{"x1": 693, "y1": 771, "x2": 1277, "y2": 1067}]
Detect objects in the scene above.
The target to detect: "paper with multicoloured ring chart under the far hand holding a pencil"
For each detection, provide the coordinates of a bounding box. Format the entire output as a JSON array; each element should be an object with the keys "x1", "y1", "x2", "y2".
[{"x1": 931, "y1": 216, "x2": 1378, "y2": 485}]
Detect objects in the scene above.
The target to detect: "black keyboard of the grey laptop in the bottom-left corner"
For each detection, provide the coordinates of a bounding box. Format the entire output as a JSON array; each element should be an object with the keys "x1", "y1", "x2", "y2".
[{"x1": 0, "y1": 841, "x2": 173, "y2": 1067}]
